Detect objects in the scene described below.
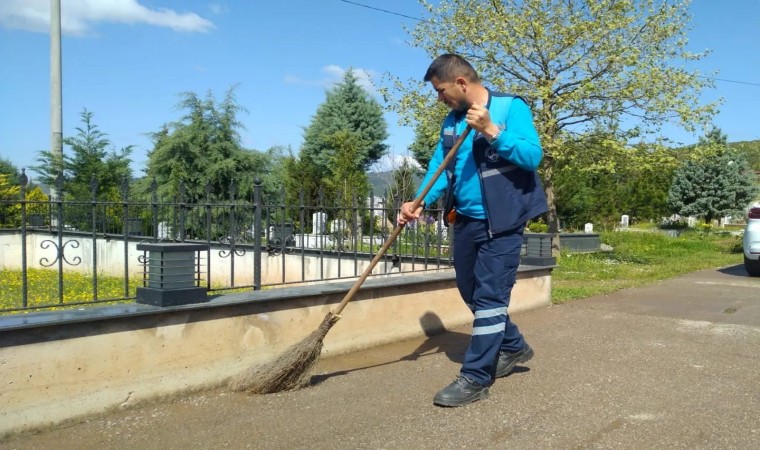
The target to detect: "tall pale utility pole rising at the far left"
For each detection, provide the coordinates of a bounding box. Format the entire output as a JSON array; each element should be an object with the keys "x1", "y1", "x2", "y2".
[{"x1": 50, "y1": 0, "x2": 63, "y2": 199}]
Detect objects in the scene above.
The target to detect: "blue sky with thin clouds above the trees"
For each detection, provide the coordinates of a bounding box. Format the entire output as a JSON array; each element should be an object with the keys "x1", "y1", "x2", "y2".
[{"x1": 0, "y1": 0, "x2": 760, "y2": 182}]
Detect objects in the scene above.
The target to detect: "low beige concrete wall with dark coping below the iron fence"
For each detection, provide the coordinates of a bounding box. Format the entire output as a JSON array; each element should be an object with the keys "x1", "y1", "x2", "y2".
[{"x1": 0, "y1": 268, "x2": 551, "y2": 433}]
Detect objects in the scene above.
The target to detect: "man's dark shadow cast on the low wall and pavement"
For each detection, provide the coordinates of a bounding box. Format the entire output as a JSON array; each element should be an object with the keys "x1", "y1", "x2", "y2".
[{"x1": 310, "y1": 311, "x2": 470, "y2": 385}]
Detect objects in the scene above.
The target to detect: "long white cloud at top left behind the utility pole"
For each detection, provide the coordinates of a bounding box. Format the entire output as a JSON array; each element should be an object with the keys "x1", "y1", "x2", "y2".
[{"x1": 0, "y1": 0, "x2": 214, "y2": 35}]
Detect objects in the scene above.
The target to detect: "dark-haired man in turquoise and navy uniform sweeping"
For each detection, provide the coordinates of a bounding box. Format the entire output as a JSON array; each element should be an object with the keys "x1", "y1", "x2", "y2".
[{"x1": 398, "y1": 54, "x2": 547, "y2": 406}]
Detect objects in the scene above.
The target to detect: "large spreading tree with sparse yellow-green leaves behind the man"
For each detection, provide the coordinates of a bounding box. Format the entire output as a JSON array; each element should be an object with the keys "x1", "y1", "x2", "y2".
[{"x1": 386, "y1": 0, "x2": 716, "y2": 231}]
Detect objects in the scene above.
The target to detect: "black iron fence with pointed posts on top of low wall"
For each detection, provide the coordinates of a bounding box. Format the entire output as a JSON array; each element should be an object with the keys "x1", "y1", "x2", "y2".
[{"x1": 0, "y1": 174, "x2": 452, "y2": 313}]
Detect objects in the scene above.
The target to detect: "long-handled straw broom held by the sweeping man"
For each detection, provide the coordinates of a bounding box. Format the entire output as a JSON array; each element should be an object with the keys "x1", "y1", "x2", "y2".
[{"x1": 230, "y1": 125, "x2": 472, "y2": 394}]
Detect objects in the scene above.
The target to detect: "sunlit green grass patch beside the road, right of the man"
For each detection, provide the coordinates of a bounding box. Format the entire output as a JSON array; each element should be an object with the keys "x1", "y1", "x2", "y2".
[{"x1": 552, "y1": 231, "x2": 742, "y2": 303}]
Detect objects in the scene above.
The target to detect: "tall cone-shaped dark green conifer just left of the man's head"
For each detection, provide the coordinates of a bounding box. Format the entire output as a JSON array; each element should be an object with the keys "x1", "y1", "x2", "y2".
[{"x1": 300, "y1": 70, "x2": 388, "y2": 177}]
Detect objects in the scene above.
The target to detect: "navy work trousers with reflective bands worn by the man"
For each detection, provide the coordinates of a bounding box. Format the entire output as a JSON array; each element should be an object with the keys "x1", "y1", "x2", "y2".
[{"x1": 454, "y1": 215, "x2": 525, "y2": 385}]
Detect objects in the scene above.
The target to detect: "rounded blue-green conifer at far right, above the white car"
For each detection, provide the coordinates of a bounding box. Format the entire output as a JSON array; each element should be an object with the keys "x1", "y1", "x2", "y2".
[{"x1": 668, "y1": 149, "x2": 757, "y2": 223}]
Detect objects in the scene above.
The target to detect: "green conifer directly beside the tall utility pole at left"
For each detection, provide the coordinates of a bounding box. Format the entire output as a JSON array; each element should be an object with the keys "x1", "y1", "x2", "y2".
[{"x1": 32, "y1": 109, "x2": 133, "y2": 200}]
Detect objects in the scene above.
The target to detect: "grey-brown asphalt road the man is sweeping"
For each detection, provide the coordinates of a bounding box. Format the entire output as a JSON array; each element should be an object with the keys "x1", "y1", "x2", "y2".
[{"x1": 0, "y1": 266, "x2": 760, "y2": 450}]
